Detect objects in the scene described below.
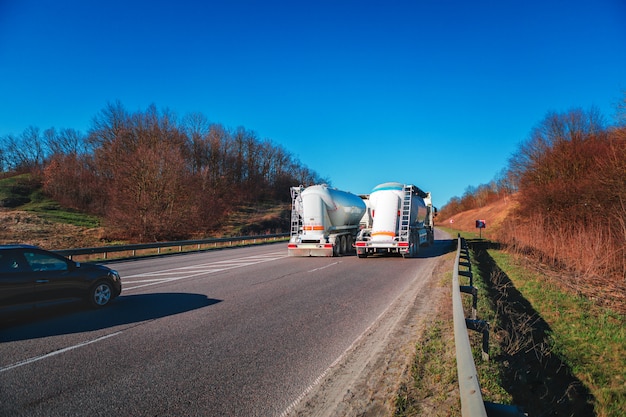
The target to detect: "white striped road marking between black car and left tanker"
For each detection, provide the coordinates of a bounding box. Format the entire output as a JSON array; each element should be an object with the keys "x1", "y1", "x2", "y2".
[{"x1": 122, "y1": 252, "x2": 288, "y2": 291}]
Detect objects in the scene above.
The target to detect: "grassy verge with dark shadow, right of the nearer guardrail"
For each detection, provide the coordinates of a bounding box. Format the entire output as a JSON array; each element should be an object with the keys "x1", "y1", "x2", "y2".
[{"x1": 434, "y1": 231, "x2": 626, "y2": 417}]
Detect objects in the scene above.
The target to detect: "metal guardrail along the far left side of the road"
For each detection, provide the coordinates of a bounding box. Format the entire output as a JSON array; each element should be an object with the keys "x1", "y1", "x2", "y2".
[{"x1": 54, "y1": 233, "x2": 289, "y2": 259}]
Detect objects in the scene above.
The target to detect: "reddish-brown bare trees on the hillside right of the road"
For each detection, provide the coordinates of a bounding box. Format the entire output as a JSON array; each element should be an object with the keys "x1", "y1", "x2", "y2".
[{"x1": 441, "y1": 99, "x2": 626, "y2": 286}]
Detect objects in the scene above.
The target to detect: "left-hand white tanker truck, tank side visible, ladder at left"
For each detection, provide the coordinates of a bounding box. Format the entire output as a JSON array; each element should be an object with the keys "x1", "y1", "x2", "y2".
[{"x1": 287, "y1": 184, "x2": 365, "y2": 256}]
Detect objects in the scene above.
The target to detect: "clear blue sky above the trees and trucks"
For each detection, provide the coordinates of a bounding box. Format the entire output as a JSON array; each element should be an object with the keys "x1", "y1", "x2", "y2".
[{"x1": 0, "y1": 0, "x2": 626, "y2": 207}]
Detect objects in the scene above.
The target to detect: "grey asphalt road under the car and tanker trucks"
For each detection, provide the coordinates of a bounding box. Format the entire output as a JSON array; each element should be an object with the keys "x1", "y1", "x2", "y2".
[{"x1": 0, "y1": 232, "x2": 445, "y2": 416}]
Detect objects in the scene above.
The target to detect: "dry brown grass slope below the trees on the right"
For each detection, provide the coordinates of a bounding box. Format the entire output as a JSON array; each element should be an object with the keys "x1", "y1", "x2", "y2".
[{"x1": 438, "y1": 195, "x2": 626, "y2": 314}]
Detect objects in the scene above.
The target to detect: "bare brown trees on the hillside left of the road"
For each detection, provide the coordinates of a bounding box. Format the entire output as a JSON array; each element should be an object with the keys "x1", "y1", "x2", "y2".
[{"x1": 0, "y1": 102, "x2": 328, "y2": 241}]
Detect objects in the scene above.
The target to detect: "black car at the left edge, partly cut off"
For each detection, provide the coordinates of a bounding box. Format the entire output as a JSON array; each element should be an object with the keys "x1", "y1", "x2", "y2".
[{"x1": 0, "y1": 245, "x2": 122, "y2": 312}]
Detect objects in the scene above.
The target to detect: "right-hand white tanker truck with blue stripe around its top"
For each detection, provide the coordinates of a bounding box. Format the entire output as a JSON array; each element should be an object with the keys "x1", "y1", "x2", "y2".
[{"x1": 355, "y1": 182, "x2": 436, "y2": 258}]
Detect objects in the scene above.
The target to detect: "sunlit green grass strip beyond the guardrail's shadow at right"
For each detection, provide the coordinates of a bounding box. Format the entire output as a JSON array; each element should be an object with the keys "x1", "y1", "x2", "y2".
[{"x1": 488, "y1": 250, "x2": 626, "y2": 417}]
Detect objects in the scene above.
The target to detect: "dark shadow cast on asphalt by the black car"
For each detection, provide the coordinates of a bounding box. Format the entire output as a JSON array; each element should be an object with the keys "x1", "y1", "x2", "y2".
[{"x1": 0, "y1": 293, "x2": 222, "y2": 343}]
